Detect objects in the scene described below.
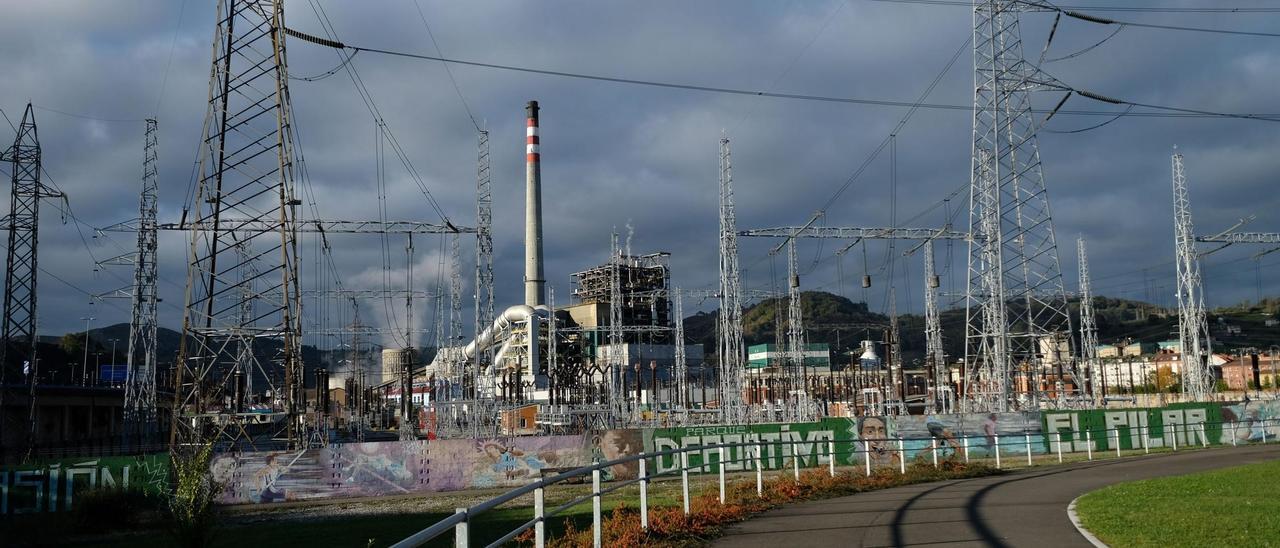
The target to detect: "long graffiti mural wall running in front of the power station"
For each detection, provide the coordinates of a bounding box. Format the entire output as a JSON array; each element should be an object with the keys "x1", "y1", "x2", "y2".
[{"x1": 0, "y1": 401, "x2": 1259, "y2": 515}]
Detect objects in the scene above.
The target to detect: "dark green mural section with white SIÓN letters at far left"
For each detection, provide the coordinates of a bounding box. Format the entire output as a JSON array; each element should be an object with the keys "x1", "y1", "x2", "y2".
[{"x1": 0, "y1": 453, "x2": 169, "y2": 516}]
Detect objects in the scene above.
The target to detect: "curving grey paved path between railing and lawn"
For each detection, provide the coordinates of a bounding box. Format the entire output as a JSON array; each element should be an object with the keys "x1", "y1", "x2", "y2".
[{"x1": 714, "y1": 444, "x2": 1280, "y2": 548}]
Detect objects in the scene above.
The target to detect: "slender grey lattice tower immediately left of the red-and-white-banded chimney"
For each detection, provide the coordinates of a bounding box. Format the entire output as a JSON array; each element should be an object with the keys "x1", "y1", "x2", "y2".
[{"x1": 462, "y1": 131, "x2": 494, "y2": 397}]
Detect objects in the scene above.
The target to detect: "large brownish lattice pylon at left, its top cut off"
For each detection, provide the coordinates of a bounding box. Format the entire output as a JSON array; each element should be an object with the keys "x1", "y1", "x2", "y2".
[{"x1": 170, "y1": 0, "x2": 303, "y2": 448}]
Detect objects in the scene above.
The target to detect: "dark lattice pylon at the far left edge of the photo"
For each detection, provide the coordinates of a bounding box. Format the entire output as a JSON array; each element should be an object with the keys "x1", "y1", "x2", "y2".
[{"x1": 0, "y1": 102, "x2": 63, "y2": 449}]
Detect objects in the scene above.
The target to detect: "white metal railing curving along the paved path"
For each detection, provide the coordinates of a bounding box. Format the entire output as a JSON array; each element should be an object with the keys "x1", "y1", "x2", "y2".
[{"x1": 393, "y1": 419, "x2": 1280, "y2": 548}]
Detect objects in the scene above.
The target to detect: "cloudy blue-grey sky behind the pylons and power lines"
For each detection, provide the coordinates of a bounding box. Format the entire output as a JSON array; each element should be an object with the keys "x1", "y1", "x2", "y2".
[{"x1": 0, "y1": 0, "x2": 1280, "y2": 346}]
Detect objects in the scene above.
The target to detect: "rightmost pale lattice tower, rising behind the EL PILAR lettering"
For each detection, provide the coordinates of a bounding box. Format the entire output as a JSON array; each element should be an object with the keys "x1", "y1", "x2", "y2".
[{"x1": 1172, "y1": 151, "x2": 1213, "y2": 401}]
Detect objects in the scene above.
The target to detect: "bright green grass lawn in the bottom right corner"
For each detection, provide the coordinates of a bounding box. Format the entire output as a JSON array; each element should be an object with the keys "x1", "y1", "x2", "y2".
[{"x1": 1076, "y1": 461, "x2": 1280, "y2": 548}]
